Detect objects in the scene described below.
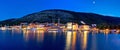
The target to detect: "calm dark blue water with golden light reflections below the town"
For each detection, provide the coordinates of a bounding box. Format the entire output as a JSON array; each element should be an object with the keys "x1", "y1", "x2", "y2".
[{"x1": 0, "y1": 30, "x2": 120, "y2": 50}]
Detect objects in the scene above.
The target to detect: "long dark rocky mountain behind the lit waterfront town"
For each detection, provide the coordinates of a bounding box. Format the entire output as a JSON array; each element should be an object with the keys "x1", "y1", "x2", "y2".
[{"x1": 0, "y1": 9, "x2": 120, "y2": 25}]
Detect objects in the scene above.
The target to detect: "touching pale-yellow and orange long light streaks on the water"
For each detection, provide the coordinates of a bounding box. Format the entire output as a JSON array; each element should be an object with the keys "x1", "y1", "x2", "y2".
[{"x1": 65, "y1": 31, "x2": 77, "y2": 50}]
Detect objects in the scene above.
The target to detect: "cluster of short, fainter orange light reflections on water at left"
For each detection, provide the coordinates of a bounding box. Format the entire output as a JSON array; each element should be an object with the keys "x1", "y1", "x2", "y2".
[{"x1": 23, "y1": 30, "x2": 44, "y2": 42}]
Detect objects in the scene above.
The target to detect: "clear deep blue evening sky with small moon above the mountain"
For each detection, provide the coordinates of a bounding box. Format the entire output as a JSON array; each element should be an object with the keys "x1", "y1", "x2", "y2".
[{"x1": 0, "y1": 0, "x2": 120, "y2": 21}]
